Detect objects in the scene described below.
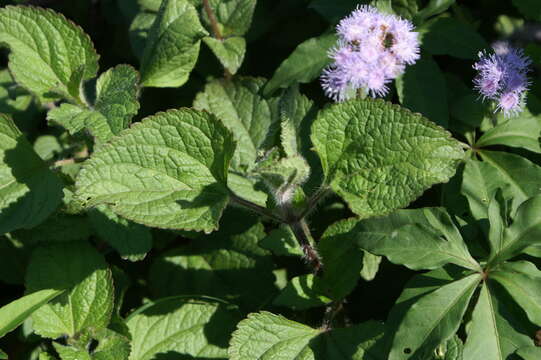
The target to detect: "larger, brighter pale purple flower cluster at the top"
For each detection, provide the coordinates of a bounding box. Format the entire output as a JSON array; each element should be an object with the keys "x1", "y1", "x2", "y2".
[{"x1": 321, "y1": 6, "x2": 419, "y2": 101}]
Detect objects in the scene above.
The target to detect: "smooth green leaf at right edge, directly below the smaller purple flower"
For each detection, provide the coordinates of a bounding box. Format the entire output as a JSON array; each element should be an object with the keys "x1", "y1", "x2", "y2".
[{"x1": 475, "y1": 117, "x2": 541, "y2": 153}]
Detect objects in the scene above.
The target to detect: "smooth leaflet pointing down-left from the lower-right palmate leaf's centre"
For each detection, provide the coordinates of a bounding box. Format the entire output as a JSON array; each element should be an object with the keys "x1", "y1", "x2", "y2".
[{"x1": 389, "y1": 274, "x2": 481, "y2": 360}]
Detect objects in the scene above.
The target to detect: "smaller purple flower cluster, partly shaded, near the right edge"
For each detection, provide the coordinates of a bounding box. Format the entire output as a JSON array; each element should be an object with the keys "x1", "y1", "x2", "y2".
[{"x1": 473, "y1": 42, "x2": 531, "y2": 116}]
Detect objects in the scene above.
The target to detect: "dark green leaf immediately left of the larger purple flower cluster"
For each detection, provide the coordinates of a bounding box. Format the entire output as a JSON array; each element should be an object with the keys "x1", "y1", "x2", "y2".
[{"x1": 264, "y1": 34, "x2": 337, "y2": 96}]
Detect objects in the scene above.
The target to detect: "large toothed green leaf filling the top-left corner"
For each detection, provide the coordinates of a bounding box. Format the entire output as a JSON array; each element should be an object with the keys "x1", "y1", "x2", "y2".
[{"x1": 0, "y1": 6, "x2": 98, "y2": 101}]
